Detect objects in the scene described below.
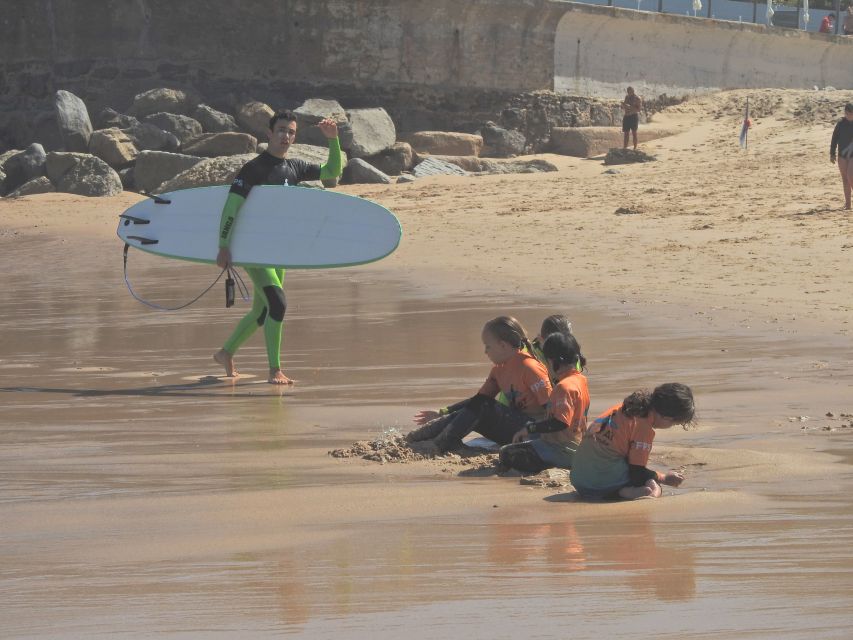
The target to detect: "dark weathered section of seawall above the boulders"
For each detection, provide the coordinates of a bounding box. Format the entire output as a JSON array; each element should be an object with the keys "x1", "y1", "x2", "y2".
[{"x1": 0, "y1": 0, "x2": 563, "y2": 107}]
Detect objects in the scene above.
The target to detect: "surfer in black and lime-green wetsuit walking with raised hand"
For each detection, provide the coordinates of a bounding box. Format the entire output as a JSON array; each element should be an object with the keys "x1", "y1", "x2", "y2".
[{"x1": 213, "y1": 111, "x2": 343, "y2": 384}]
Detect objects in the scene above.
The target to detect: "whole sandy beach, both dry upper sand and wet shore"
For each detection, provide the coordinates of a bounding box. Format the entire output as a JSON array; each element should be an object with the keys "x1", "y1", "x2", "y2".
[{"x1": 0, "y1": 90, "x2": 853, "y2": 639}]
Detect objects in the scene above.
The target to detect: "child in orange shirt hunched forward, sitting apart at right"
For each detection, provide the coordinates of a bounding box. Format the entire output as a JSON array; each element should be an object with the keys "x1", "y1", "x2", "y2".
[{"x1": 571, "y1": 382, "x2": 695, "y2": 500}]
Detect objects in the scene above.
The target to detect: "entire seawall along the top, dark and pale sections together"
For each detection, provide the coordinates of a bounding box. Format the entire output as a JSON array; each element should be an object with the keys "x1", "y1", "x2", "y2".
[{"x1": 0, "y1": 0, "x2": 853, "y2": 146}]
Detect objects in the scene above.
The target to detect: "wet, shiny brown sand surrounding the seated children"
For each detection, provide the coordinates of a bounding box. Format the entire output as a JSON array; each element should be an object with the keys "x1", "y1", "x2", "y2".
[{"x1": 0, "y1": 246, "x2": 853, "y2": 639}]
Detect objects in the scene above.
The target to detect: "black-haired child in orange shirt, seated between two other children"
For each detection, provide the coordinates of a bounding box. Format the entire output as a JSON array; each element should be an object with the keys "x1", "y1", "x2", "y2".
[{"x1": 499, "y1": 333, "x2": 589, "y2": 473}]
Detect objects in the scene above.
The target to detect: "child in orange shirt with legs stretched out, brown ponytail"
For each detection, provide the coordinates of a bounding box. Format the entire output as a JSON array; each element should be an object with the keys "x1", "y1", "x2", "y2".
[{"x1": 407, "y1": 316, "x2": 551, "y2": 455}]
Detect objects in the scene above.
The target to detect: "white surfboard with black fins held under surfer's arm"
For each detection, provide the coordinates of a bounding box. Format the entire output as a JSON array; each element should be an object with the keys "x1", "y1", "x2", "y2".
[{"x1": 117, "y1": 185, "x2": 402, "y2": 269}]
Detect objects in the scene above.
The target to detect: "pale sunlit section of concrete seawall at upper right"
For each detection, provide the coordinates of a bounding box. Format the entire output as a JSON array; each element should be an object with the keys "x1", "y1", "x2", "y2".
[{"x1": 554, "y1": 4, "x2": 853, "y2": 97}]
